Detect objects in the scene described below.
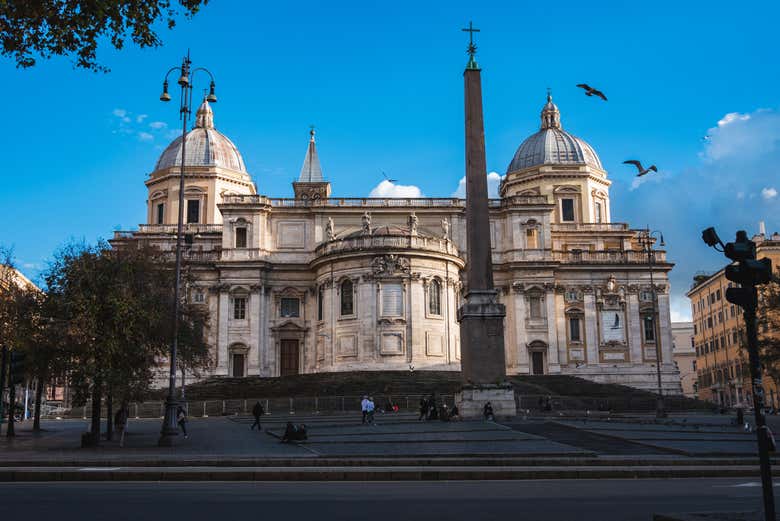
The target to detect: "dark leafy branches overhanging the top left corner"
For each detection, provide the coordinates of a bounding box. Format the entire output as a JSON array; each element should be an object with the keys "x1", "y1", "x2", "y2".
[{"x1": 0, "y1": 0, "x2": 208, "y2": 72}]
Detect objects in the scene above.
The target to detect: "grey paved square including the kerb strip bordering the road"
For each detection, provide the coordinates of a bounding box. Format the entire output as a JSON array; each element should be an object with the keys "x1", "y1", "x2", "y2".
[{"x1": 0, "y1": 414, "x2": 758, "y2": 481}]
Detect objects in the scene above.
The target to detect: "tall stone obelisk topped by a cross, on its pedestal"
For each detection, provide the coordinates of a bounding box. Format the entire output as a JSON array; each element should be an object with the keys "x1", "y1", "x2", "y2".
[{"x1": 455, "y1": 23, "x2": 517, "y2": 417}]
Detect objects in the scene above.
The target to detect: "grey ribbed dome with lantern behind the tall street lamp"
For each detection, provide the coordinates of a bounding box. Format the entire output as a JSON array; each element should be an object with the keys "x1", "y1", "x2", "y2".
[{"x1": 154, "y1": 100, "x2": 246, "y2": 173}]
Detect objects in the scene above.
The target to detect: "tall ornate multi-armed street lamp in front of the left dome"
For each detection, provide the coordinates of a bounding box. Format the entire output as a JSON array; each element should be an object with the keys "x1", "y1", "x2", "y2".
[{"x1": 158, "y1": 51, "x2": 217, "y2": 446}]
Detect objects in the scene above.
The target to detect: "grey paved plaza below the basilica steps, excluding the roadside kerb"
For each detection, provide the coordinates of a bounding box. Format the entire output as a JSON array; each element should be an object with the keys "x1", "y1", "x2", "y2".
[{"x1": 0, "y1": 413, "x2": 776, "y2": 464}]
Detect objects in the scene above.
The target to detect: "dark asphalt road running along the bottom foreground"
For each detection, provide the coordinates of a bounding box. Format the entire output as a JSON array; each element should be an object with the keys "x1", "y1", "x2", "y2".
[{"x1": 0, "y1": 479, "x2": 761, "y2": 521}]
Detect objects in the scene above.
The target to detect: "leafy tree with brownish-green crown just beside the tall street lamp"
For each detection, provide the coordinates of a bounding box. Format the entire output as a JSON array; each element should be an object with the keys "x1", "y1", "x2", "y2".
[{"x1": 46, "y1": 243, "x2": 208, "y2": 444}]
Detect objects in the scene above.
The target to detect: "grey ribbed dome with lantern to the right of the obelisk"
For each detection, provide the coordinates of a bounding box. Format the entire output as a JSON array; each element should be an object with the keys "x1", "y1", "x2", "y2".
[{"x1": 507, "y1": 94, "x2": 602, "y2": 173}]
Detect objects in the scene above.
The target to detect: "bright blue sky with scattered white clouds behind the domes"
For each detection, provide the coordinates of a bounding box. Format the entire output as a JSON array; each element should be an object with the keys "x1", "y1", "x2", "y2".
[{"x1": 0, "y1": 0, "x2": 780, "y2": 318}]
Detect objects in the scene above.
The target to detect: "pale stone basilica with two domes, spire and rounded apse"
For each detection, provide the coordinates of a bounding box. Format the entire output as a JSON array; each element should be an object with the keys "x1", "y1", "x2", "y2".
[{"x1": 112, "y1": 96, "x2": 681, "y2": 394}]
